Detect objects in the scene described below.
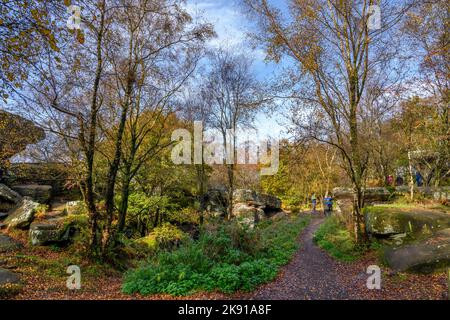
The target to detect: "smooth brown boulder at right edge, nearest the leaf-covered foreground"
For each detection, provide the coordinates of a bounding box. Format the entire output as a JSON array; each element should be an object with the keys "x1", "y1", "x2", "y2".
[{"x1": 385, "y1": 228, "x2": 450, "y2": 273}]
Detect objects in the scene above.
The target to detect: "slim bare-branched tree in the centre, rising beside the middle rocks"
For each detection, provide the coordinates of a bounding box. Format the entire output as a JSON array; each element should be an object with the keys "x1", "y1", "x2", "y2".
[{"x1": 202, "y1": 49, "x2": 264, "y2": 218}]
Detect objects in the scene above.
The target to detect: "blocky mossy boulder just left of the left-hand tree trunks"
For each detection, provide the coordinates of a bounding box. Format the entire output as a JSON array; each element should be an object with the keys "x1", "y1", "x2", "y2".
[{"x1": 30, "y1": 218, "x2": 76, "y2": 246}]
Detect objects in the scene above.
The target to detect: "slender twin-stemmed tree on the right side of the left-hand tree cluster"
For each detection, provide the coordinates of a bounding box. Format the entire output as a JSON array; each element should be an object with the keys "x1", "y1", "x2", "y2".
[{"x1": 97, "y1": 0, "x2": 213, "y2": 250}]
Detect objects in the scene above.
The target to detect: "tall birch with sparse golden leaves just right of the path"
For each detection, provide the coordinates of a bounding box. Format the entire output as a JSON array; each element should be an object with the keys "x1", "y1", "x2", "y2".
[{"x1": 245, "y1": 0, "x2": 407, "y2": 243}]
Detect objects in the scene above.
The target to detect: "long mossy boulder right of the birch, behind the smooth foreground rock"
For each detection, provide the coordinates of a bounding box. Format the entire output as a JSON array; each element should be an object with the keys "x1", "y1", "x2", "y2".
[{"x1": 366, "y1": 206, "x2": 450, "y2": 236}]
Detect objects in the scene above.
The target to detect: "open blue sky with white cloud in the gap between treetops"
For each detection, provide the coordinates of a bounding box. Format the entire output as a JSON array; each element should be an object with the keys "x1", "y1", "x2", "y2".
[{"x1": 187, "y1": 0, "x2": 287, "y2": 138}]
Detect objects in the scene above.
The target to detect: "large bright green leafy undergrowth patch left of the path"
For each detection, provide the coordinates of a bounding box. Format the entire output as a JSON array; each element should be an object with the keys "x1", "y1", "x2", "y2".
[{"x1": 123, "y1": 217, "x2": 309, "y2": 296}]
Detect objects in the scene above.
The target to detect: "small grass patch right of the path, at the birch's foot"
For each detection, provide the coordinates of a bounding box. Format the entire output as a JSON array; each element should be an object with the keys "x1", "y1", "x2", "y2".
[{"x1": 314, "y1": 216, "x2": 361, "y2": 262}]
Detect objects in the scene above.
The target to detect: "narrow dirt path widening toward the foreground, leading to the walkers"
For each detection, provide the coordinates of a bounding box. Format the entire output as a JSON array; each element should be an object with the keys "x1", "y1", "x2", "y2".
[{"x1": 253, "y1": 218, "x2": 348, "y2": 300}]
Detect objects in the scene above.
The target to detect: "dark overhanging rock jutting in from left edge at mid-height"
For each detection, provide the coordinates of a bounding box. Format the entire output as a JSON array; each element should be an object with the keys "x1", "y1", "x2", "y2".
[{"x1": 0, "y1": 110, "x2": 45, "y2": 164}]
